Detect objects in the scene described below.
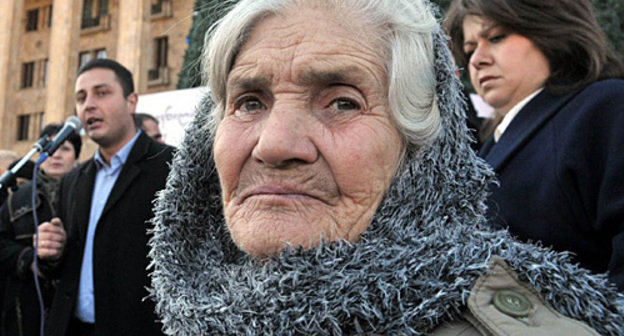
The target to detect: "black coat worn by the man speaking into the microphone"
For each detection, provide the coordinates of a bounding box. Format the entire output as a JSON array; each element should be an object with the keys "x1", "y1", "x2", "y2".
[{"x1": 46, "y1": 133, "x2": 173, "y2": 336}]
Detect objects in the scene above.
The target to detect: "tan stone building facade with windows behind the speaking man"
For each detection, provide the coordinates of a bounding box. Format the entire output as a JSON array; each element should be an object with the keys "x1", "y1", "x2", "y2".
[{"x1": 0, "y1": 0, "x2": 194, "y2": 158}]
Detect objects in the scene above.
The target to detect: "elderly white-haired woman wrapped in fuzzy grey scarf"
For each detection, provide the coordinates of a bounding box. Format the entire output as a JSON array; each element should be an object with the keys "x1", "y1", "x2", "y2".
[{"x1": 150, "y1": 0, "x2": 624, "y2": 335}]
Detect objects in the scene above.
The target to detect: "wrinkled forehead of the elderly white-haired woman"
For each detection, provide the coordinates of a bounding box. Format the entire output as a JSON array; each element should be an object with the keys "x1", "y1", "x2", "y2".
[{"x1": 228, "y1": 9, "x2": 385, "y2": 87}]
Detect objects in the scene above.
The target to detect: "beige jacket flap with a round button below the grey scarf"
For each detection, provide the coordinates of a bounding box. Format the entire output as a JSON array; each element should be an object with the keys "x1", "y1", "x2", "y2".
[{"x1": 431, "y1": 258, "x2": 599, "y2": 336}]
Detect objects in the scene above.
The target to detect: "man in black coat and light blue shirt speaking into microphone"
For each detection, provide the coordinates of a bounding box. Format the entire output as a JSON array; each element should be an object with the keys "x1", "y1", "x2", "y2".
[{"x1": 38, "y1": 59, "x2": 173, "y2": 336}]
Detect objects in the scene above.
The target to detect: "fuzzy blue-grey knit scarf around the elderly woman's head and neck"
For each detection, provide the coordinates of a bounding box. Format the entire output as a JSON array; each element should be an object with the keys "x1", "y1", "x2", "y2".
[{"x1": 150, "y1": 3, "x2": 624, "y2": 335}]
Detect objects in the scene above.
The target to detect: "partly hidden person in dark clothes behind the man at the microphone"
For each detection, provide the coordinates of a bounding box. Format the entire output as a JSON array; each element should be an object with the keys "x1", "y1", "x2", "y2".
[{"x1": 0, "y1": 124, "x2": 82, "y2": 335}]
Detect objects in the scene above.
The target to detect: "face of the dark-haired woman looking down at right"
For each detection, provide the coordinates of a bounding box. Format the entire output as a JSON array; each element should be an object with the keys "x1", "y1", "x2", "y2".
[{"x1": 463, "y1": 15, "x2": 550, "y2": 115}]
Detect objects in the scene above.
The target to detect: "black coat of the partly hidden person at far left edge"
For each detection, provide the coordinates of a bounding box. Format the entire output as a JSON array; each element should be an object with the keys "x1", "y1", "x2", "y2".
[{"x1": 0, "y1": 182, "x2": 55, "y2": 335}]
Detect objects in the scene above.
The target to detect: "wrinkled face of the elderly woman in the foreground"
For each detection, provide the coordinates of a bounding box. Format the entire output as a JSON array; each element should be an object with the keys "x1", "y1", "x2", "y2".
[{"x1": 214, "y1": 8, "x2": 403, "y2": 257}]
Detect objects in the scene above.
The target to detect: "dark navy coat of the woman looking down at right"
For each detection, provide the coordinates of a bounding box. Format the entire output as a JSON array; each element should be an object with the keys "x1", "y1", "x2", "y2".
[{"x1": 479, "y1": 80, "x2": 624, "y2": 290}]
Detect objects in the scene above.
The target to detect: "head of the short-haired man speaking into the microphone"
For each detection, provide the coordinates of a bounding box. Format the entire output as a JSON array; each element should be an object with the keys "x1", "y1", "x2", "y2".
[{"x1": 75, "y1": 68, "x2": 137, "y2": 148}]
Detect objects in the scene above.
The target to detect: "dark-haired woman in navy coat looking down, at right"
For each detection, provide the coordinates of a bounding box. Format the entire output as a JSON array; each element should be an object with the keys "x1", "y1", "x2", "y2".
[{"x1": 445, "y1": 0, "x2": 624, "y2": 290}]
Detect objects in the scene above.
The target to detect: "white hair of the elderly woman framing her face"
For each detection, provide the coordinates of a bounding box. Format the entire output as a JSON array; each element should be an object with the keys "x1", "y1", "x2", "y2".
[{"x1": 202, "y1": 0, "x2": 440, "y2": 147}]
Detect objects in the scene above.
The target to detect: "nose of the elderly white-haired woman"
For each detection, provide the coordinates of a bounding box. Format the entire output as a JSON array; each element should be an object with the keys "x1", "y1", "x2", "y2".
[{"x1": 252, "y1": 105, "x2": 319, "y2": 168}]
